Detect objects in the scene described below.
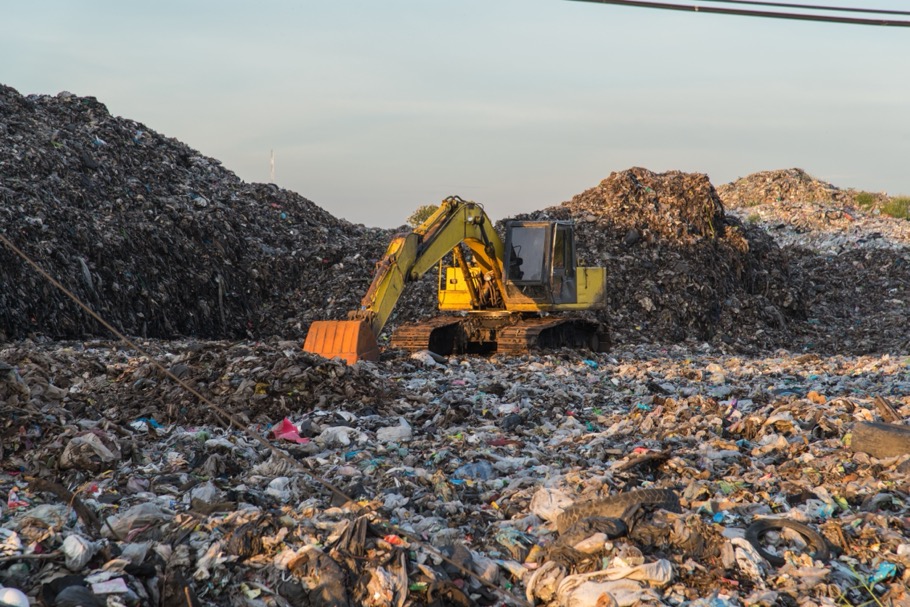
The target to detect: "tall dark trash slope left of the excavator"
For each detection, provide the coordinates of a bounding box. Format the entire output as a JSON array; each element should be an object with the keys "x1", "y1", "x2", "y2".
[{"x1": 0, "y1": 85, "x2": 388, "y2": 339}]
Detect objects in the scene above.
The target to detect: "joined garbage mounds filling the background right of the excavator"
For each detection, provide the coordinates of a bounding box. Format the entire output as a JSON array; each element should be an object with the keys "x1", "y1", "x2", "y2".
[{"x1": 506, "y1": 168, "x2": 910, "y2": 354}]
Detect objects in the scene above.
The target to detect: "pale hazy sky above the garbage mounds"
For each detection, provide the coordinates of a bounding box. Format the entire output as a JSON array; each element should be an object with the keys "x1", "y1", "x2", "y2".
[{"x1": 0, "y1": 0, "x2": 910, "y2": 227}]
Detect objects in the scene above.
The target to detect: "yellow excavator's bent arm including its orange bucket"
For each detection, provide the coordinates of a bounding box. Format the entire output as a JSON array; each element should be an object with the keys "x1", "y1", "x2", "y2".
[{"x1": 303, "y1": 196, "x2": 505, "y2": 363}]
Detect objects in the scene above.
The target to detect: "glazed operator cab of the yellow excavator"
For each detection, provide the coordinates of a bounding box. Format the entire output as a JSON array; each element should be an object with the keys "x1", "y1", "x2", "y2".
[{"x1": 503, "y1": 221, "x2": 577, "y2": 304}]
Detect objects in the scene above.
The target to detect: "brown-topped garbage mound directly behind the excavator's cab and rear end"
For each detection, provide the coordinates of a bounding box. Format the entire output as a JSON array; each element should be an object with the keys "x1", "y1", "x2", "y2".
[{"x1": 510, "y1": 168, "x2": 806, "y2": 351}]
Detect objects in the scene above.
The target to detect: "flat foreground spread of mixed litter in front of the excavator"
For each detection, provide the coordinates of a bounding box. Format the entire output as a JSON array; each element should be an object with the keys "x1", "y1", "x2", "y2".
[{"x1": 0, "y1": 340, "x2": 910, "y2": 607}]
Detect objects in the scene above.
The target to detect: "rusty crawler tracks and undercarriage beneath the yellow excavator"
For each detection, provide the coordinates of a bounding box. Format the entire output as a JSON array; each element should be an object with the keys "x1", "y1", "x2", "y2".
[{"x1": 391, "y1": 314, "x2": 609, "y2": 356}]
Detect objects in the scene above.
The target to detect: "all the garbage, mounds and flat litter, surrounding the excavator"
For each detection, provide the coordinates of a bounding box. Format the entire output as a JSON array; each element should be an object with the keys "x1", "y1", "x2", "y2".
[{"x1": 0, "y1": 87, "x2": 910, "y2": 607}]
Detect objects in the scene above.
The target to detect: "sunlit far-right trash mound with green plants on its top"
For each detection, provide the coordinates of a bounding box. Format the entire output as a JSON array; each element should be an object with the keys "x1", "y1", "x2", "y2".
[{"x1": 718, "y1": 169, "x2": 910, "y2": 354}]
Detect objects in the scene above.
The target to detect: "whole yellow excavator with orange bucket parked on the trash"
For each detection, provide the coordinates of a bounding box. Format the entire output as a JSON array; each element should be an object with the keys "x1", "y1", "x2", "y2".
[{"x1": 303, "y1": 196, "x2": 608, "y2": 364}]
